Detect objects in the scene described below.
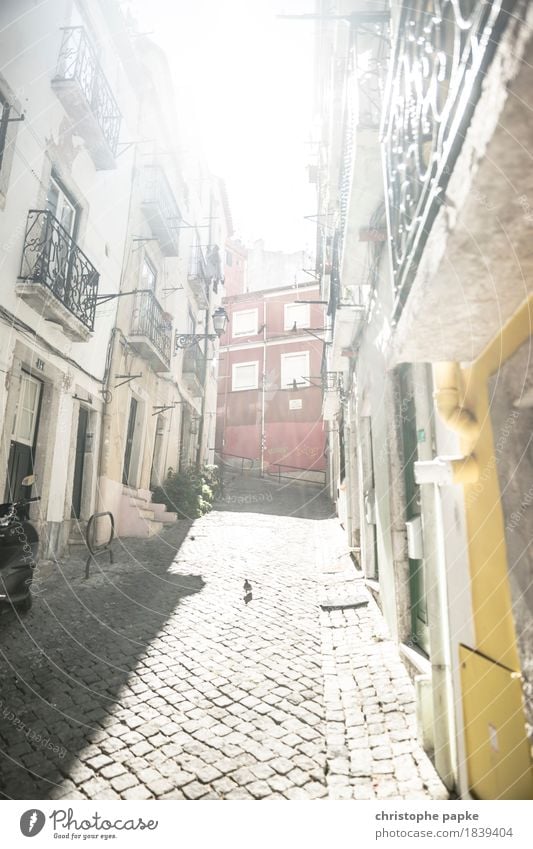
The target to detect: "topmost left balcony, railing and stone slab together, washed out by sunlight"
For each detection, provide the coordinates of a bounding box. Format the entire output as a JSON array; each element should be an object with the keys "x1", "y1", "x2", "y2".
[{"x1": 52, "y1": 27, "x2": 122, "y2": 170}]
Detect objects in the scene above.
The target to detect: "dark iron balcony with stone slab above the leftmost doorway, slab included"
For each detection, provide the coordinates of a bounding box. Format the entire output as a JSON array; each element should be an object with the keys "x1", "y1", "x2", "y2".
[{"x1": 16, "y1": 209, "x2": 99, "y2": 342}]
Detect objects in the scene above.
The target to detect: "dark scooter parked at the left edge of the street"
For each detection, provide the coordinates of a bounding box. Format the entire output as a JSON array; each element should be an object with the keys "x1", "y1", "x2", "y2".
[{"x1": 0, "y1": 475, "x2": 40, "y2": 613}]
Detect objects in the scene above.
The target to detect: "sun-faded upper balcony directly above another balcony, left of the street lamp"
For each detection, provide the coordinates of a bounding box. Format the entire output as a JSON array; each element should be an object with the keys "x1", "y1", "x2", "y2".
[{"x1": 141, "y1": 164, "x2": 181, "y2": 256}]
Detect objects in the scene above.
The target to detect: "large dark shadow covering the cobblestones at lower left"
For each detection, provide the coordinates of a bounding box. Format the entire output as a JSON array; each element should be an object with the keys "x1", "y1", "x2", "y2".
[{"x1": 0, "y1": 522, "x2": 200, "y2": 799}]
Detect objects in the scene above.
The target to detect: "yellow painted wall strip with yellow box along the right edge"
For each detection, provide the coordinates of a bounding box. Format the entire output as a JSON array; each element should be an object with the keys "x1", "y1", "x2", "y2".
[{"x1": 454, "y1": 298, "x2": 533, "y2": 799}]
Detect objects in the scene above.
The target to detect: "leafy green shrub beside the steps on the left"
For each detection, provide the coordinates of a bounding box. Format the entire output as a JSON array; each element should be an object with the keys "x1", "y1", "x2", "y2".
[{"x1": 152, "y1": 465, "x2": 220, "y2": 519}]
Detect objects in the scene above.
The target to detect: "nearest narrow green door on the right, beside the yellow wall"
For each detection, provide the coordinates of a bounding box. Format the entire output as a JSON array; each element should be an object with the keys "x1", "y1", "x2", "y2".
[{"x1": 399, "y1": 366, "x2": 429, "y2": 654}]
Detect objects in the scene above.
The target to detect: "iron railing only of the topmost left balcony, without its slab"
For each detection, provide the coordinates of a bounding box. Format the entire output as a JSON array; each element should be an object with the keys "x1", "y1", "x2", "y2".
[{"x1": 55, "y1": 27, "x2": 122, "y2": 154}]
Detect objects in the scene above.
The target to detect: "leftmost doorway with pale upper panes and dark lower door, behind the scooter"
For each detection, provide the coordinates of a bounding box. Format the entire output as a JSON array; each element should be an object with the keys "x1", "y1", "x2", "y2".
[{"x1": 5, "y1": 372, "x2": 43, "y2": 501}]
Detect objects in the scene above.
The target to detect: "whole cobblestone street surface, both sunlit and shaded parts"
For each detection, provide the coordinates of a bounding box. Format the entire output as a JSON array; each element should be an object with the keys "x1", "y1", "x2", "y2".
[{"x1": 0, "y1": 479, "x2": 446, "y2": 800}]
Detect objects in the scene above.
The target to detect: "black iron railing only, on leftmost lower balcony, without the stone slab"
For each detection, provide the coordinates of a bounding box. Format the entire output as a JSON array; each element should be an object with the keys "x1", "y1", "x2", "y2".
[{"x1": 19, "y1": 209, "x2": 100, "y2": 330}]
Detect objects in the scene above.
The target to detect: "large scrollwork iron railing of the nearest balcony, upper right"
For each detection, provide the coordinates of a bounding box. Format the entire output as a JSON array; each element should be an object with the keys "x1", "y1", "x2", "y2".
[{"x1": 384, "y1": 0, "x2": 515, "y2": 315}]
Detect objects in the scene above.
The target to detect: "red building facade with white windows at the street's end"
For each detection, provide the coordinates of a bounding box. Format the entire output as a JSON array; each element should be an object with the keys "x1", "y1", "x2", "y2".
[{"x1": 216, "y1": 286, "x2": 325, "y2": 477}]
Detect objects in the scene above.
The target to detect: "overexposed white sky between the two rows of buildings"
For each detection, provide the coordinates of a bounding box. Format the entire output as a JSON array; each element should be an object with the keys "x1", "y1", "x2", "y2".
[{"x1": 132, "y1": 0, "x2": 316, "y2": 251}]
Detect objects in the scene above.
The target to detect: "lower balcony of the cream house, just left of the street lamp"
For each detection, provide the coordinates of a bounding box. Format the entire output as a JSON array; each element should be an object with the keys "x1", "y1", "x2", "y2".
[{"x1": 130, "y1": 292, "x2": 172, "y2": 372}]
